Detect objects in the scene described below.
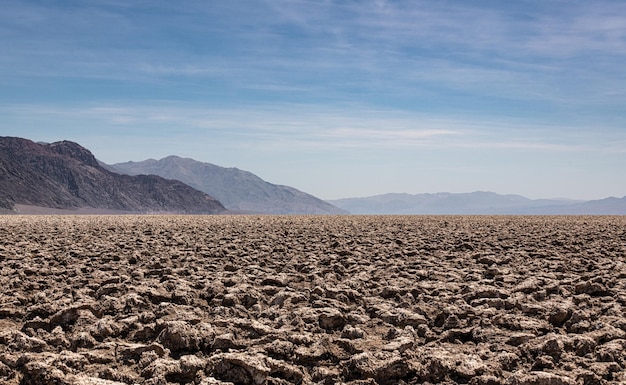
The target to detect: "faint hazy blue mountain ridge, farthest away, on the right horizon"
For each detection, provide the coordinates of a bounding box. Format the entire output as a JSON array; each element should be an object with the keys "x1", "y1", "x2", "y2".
[{"x1": 328, "y1": 191, "x2": 626, "y2": 215}]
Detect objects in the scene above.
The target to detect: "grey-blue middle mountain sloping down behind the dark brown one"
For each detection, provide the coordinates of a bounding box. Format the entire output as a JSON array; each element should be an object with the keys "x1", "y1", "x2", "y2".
[{"x1": 109, "y1": 156, "x2": 347, "y2": 214}]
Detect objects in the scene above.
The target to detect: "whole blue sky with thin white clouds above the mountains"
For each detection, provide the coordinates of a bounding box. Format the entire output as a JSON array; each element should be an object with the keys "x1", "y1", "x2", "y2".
[{"x1": 0, "y1": 0, "x2": 626, "y2": 200}]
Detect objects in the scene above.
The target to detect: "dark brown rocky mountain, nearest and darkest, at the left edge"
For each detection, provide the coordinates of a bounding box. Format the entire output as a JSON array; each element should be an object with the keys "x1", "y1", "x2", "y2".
[{"x1": 0, "y1": 137, "x2": 226, "y2": 214}]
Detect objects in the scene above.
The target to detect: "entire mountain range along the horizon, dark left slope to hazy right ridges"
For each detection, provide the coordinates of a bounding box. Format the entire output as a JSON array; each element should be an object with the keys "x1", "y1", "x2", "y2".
[{"x1": 0, "y1": 137, "x2": 626, "y2": 215}]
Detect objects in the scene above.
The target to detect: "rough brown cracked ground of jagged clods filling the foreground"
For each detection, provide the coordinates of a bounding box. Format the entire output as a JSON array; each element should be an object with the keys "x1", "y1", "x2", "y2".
[{"x1": 0, "y1": 216, "x2": 626, "y2": 385}]
